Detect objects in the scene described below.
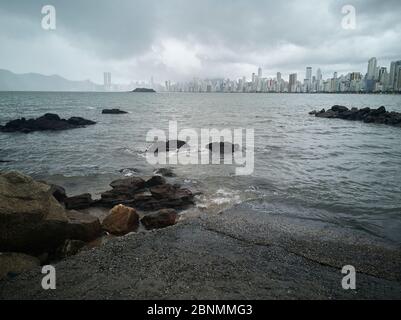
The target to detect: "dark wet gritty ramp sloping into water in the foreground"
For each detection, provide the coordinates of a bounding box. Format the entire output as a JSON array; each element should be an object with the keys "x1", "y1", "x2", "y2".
[{"x1": 0, "y1": 200, "x2": 401, "y2": 300}]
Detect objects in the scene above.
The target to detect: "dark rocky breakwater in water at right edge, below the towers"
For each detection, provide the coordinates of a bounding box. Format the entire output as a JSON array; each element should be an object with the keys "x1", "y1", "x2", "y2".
[{"x1": 309, "y1": 105, "x2": 401, "y2": 128}]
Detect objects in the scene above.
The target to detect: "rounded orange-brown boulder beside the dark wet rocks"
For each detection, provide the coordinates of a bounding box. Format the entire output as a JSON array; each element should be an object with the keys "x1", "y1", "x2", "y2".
[{"x1": 102, "y1": 205, "x2": 139, "y2": 236}]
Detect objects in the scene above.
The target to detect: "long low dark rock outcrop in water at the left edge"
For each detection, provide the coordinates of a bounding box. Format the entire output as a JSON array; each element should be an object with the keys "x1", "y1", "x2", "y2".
[{"x1": 0, "y1": 113, "x2": 96, "y2": 133}]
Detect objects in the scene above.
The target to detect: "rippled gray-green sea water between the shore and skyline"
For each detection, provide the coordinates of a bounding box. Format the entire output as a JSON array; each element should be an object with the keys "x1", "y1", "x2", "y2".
[{"x1": 0, "y1": 92, "x2": 401, "y2": 243}]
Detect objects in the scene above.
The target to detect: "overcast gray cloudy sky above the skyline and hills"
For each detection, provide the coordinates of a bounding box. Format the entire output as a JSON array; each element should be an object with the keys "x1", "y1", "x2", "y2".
[{"x1": 0, "y1": 0, "x2": 401, "y2": 83}]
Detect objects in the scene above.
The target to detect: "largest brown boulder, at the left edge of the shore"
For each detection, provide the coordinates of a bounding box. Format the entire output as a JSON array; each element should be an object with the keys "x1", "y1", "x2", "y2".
[{"x1": 0, "y1": 172, "x2": 101, "y2": 254}]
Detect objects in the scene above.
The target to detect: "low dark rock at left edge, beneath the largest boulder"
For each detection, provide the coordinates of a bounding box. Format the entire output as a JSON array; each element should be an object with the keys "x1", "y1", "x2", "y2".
[{"x1": 0, "y1": 253, "x2": 40, "y2": 280}]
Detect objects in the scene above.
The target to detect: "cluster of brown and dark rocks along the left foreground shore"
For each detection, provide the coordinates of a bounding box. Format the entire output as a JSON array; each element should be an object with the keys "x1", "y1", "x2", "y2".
[{"x1": 0, "y1": 172, "x2": 194, "y2": 277}]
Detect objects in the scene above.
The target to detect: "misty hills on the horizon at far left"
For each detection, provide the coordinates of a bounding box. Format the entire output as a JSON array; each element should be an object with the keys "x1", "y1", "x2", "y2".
[{"x1": 0, "y1": 69, "x2": 103, "y2": 91}]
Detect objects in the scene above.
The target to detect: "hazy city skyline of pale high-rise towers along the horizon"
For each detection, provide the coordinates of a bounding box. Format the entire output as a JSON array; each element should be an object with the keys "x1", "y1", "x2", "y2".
[{"x1": 104, "y1": 57, "x2": 401, "y2": 93}]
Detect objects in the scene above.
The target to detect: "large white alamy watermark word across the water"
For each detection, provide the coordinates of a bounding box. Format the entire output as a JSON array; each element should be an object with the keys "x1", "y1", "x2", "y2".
[{"x1": 146, "y1": 121, "x2": 255, "y2": 176}]
